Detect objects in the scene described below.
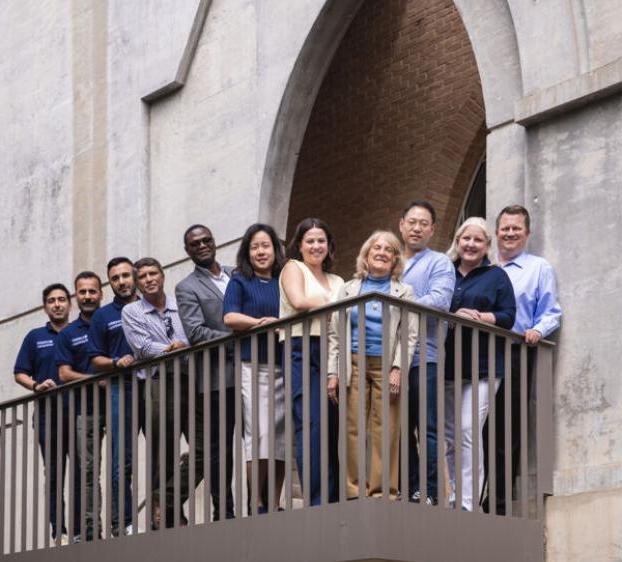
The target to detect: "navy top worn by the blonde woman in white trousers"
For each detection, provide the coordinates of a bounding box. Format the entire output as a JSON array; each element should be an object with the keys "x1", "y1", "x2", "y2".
[{"x1": 445, "y1": 259, "x2": 516, "y2": 380}]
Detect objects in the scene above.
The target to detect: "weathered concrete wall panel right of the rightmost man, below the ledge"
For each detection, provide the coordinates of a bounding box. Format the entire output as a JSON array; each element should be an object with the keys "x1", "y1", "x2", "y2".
[{"x1": 527, "y1": 97, "x2": 622, "y2": 494}]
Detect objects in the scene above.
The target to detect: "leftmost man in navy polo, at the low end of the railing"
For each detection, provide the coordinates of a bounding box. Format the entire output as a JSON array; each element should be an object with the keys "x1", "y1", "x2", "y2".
[{"x1": 13, "y1": 283, "x2": 80, "y2": 538}]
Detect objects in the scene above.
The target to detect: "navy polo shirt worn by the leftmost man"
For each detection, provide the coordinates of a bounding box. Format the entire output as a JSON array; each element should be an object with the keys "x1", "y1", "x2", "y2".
[{"x1": 13, "y1": 322, "x2": 62, "y2": 385}]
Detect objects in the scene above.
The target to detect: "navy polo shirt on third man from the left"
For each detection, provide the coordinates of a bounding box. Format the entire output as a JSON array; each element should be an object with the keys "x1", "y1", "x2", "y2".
[{"x1": 87, "y1": 297, "x2": 133, "y2": 360}]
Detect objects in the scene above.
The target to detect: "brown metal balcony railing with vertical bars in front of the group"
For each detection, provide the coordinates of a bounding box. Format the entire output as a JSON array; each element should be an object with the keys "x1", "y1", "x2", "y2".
[{"x1": 0, "y1": 293, "x2": 553, "y2": 560}]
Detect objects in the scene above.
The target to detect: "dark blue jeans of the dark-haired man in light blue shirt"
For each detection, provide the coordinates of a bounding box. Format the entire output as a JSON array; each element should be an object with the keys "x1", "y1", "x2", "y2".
[{"x1": 408, "y1": 363, "x2": 438, "y2": 499}]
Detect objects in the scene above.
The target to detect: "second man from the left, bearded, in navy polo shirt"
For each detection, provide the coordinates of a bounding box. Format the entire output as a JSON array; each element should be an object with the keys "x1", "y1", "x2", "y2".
[{"x1": 56, "y1": 271, "x2": 102, "y2": 540}]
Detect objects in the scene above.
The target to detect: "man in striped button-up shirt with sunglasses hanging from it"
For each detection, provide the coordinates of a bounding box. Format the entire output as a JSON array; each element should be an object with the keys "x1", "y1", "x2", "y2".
[{"x1": 121, "y1": 258, "x2": 190, "y2": 528}]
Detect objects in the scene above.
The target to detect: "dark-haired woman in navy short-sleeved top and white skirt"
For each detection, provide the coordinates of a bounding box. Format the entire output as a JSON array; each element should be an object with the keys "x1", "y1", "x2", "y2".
[{"x1": 223, "y1": 224, "x2": 285, "y2": 513}]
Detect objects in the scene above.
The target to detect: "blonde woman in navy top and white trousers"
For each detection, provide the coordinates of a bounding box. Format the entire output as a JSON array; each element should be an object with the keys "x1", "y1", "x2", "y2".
[{"x1": 445, "y1": 217, "x2": 516, "y2": 511}]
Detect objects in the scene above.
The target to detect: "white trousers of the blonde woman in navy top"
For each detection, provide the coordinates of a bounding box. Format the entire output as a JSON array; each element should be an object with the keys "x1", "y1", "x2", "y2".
[{"x1": 445, "y1": 377, "x2": 501, "y2": 511}]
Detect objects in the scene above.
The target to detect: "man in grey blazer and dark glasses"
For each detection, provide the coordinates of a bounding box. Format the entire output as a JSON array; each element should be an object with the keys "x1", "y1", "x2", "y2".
[{"x1": 175, "y1": 224, "x2": 235, "y2": 521}]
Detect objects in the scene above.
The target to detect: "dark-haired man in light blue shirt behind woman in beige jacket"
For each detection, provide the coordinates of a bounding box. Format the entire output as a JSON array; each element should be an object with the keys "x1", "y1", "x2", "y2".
[{"x1": 399, "y1": 201, "x2": 456, "y2": 504}]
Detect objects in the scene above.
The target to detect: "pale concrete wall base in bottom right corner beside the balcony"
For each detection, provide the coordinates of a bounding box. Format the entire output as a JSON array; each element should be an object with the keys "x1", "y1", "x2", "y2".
[{"x1": 546, "y1": 488, "x2": 622, "y2": 562}]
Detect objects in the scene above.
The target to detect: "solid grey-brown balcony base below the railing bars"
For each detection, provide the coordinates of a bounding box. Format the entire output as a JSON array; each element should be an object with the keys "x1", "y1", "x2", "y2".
[{"x1": 4, "y1": 499, "x2": 544, "y2": 562}]
